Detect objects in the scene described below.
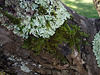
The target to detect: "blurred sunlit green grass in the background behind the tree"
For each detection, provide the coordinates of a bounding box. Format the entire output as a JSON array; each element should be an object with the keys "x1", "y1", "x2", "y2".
[{"x1": 61, "y1": 0, "x2": 99, "y2": 18}]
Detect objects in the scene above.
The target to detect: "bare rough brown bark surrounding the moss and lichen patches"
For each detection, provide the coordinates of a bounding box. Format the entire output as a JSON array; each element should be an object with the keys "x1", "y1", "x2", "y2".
[{"x1": 0, "y1": 0, "x2": 100, "y2": 75}]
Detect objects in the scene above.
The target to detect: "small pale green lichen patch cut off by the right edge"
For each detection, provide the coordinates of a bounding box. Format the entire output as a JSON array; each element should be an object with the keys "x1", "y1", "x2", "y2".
[{"x1": 93, "y1": 31, "x2": 100, "y2": 67}]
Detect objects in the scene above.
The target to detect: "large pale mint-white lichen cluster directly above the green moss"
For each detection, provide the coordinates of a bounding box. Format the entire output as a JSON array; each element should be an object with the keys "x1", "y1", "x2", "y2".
[{"x1": 2, "y1": 0, "x2": 70, "y2": 38}]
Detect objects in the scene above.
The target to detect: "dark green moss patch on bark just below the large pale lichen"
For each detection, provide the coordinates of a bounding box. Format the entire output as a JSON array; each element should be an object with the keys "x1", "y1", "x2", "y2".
[{"x1": 23, "y1": 22, "x2": 88, "y2": 61}]
